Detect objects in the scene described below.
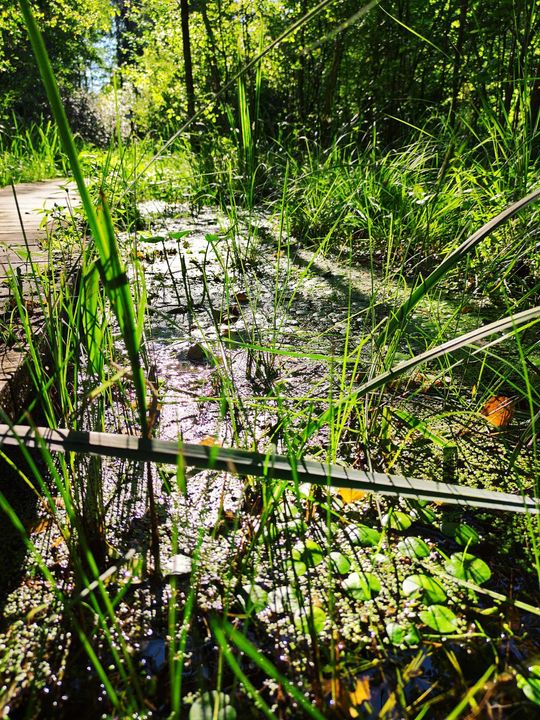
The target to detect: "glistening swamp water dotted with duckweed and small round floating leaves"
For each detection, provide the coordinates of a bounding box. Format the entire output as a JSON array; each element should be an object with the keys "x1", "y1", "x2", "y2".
[{"x1": 0, "y1": 205, "x2": 540, "y2": 718}]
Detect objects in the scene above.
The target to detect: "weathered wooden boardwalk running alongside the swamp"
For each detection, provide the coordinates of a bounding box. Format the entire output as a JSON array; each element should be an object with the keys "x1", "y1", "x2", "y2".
[{"x1": 0, "y1": 178, "x2": 78, "y2": 419}]
